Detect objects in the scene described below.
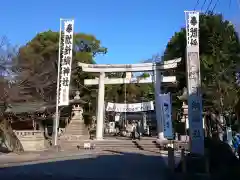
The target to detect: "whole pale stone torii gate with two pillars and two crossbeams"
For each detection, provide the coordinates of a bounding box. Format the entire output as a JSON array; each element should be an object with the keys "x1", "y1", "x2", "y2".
[{"x1": 78, "y1": 58, "x2": 181, "y2": 140}]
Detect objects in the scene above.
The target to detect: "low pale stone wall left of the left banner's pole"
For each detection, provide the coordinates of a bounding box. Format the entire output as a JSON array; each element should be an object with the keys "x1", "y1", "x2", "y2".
[{"x1": 14, "y1": 130, "x2": 46, "y2": 151}]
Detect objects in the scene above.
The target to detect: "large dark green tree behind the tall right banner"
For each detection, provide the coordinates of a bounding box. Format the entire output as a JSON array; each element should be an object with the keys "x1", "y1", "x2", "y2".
[{"x1": 163, "y1": 13, "x2": 240, "y2": 115}]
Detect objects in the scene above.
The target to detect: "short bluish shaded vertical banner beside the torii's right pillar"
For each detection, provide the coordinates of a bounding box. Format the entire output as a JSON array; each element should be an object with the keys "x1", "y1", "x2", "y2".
[{"x1": 159, "y1": 93, "x2": 173, "y2": 139}]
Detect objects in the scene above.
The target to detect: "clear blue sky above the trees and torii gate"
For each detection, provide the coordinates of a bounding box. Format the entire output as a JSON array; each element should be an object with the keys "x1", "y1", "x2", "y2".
[{"x1": 0, "y1": 0, "x2": 240, "y2": 63}]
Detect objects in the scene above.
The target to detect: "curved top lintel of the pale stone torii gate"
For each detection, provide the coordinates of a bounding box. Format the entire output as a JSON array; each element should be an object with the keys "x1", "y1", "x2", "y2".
[{"x1": 78, "y1": 58, "x2": 181, "y2": 72}]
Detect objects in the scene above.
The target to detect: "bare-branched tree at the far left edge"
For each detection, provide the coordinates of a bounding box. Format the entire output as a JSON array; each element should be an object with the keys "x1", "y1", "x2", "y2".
[{"x1": 0, "y1": 37, "x2": 23, "y2": 152}]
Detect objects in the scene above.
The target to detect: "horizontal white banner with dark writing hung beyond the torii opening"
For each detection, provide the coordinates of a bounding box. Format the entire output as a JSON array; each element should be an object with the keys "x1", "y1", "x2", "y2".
[{"x1": 106, "y1": 101, "x2": 154, "y2": 112}]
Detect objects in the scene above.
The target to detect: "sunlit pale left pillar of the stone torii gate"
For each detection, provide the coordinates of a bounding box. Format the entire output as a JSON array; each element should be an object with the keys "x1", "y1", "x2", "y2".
[{"x1": 96, "y1": 72, "x2": 105, "y2": 140}]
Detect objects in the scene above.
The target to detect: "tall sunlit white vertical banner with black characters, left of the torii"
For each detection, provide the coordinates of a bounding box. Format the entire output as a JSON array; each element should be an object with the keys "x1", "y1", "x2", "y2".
[{"x1": 58, "y1": 20, "x2": 74, "y2": 106}]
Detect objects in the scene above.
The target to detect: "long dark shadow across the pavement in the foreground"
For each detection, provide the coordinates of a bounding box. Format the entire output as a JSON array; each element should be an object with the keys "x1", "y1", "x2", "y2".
[{"x1": 0, "y1": 152, "x2": 170, "y2": 180}]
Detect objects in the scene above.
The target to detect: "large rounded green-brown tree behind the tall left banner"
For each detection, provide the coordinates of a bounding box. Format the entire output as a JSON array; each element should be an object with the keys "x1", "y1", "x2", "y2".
[{"x1": 14, "y1": 31, "x2": 106, "y2": 105}]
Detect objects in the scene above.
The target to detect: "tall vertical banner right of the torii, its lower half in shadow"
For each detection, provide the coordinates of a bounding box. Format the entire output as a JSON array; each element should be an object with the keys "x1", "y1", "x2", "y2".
[{"x1": 185, "y1": 11, "x2": 204, "y2": 155}]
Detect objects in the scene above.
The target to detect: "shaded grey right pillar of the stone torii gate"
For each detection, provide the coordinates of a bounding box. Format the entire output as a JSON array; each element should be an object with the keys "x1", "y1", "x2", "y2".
[{"x1": 154, "y1": 70, "x2": 165, "y2": 140}]
